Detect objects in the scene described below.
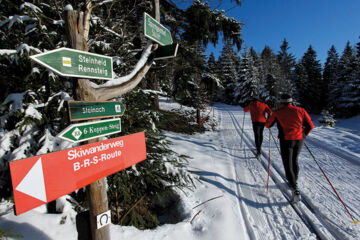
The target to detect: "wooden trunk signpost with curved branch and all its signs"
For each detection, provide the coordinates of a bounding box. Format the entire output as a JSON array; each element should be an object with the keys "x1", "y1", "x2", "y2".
[{"x1": 18, "y1": 0, "x2": 172, "y2": 240}]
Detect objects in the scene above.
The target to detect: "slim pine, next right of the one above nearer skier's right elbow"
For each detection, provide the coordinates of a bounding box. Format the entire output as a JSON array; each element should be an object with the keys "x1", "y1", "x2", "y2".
[{"x1": 323, "y1": 45, "x2": 339, "y2": 109}]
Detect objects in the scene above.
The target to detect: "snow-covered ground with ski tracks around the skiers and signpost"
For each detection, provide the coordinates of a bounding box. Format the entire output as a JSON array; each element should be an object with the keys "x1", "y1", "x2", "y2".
[{"x1": 0, "y1": 99, "x2": 360, "y2": 240}]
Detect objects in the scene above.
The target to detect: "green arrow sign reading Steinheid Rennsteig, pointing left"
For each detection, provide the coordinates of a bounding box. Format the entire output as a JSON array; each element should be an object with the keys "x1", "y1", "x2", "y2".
[{"x1": 30, "y1": 48, "x2": 113, "y2": 80}]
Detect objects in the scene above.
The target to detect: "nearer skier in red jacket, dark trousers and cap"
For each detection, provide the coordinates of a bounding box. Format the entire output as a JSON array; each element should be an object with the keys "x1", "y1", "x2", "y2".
[{"x1": 265, "y1": 94, "x2": 314, "y2": 203}]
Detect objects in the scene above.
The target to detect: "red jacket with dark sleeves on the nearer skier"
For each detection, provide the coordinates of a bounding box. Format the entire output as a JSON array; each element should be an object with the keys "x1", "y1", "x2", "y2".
[{"x1": 265, "y1": 104, "x2": 314, "y2": 140}]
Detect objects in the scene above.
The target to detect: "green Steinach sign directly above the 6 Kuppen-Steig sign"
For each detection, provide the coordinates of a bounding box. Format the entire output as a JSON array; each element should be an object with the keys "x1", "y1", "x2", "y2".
[{"x1": 68, "y1": 101, "x2": 125, "y2": 121}]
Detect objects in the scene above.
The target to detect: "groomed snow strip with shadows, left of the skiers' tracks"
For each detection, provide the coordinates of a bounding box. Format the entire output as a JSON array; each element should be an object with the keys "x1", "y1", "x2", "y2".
[{"x1": 214, "y1": 105, "x2": 315, "y2": 239}]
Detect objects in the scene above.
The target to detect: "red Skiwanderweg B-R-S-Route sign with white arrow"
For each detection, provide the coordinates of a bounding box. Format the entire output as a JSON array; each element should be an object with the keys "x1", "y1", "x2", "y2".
[{"x1": 10, "y1": 132, "x2": 146, "y2": 215}]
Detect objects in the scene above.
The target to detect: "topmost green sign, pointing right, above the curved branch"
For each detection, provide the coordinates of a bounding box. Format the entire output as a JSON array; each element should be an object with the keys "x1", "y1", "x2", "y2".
[{"x1": 144, "y1": 13, "x2": 173, "y2": 46}]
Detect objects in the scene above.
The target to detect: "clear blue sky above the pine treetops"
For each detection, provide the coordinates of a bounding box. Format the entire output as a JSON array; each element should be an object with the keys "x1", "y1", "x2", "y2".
[{"x1": 207, "y1": 0, "x2": 360, "y2": 63}]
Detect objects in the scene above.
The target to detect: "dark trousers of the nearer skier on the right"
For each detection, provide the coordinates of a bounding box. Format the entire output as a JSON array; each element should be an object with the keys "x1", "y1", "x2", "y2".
[{"x1": 280, "y1": 139, "x2": 304, "y2": 189}]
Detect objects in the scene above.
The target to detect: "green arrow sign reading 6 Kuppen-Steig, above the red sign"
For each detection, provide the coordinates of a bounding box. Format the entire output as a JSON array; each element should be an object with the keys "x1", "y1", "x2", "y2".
[{"x1": 57, "y1": 118, "x2": 121, "y2": 143}]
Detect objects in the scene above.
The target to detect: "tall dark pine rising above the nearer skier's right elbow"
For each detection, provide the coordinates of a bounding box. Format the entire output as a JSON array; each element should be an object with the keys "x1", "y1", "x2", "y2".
[{"x1": 301, "y1": 45, "x2": 324, "y2": 113}]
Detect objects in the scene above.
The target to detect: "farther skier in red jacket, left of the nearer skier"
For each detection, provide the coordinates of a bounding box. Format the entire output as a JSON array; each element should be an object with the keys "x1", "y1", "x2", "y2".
[{"x1": 244, "y1": 98, "x2": 271, "y2": 158}]
